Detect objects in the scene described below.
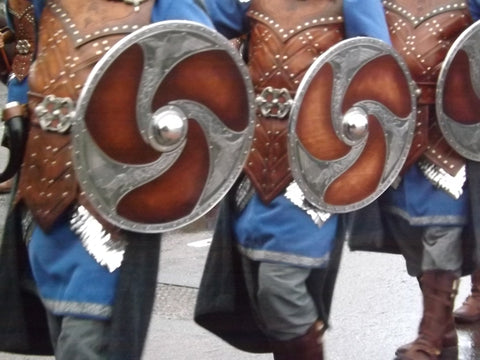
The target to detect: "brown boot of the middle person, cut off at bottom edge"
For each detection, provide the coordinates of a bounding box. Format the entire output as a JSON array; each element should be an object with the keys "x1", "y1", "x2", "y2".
[{"x1": 271, "y1": 321, "x2": 325, "y2": 360}]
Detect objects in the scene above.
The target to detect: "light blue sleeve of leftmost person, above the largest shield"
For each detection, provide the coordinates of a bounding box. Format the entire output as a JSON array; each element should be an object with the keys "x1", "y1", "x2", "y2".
[{"x1": 151, "y1": 0, "x2": 213, "y2": 28}]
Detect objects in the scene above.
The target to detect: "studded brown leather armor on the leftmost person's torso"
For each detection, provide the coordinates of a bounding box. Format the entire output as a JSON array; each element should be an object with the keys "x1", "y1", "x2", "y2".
[{"x1": 16, "y1": 0, "x2": 153, "y2": 230}]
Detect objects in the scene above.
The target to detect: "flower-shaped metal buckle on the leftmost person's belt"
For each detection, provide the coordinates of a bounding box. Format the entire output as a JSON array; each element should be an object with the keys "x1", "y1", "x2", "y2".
[{"x1": 35, "y1": 95, "x2": 75, "y2": 134}]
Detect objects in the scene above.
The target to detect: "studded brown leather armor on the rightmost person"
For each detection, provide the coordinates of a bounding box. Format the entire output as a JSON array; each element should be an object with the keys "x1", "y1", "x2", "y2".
[{"x1": 383, "y1": 0, "x2": 472, "y2": 175}]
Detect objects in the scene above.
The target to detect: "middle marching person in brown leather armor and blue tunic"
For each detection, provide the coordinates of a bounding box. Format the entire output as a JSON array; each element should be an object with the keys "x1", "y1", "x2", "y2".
[{"x1": 195, "y1": 0, "x2": 400, "y2": 359}]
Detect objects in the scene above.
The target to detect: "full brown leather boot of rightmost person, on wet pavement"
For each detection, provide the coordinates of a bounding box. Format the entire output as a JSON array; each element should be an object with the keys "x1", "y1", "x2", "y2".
[{"x1": 395, "y1": 270, "x2": 458, "y2": 360}]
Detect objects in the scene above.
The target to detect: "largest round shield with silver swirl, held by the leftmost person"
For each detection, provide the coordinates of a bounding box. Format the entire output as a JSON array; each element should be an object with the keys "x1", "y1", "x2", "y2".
[{"x1": 72, "y1": 21, "x2": 254, "y2": 233}]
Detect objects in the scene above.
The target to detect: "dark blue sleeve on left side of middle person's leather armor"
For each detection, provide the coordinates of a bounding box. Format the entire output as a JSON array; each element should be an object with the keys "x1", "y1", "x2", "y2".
[{"x1": 205, "y1": 0, "x2": 250, "y2": 39}]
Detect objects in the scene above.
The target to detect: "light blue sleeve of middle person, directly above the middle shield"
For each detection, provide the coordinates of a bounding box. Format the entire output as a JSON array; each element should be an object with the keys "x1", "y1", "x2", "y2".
[{"x1": 343, "y1": 0, "x2": 391, "y2": 44}]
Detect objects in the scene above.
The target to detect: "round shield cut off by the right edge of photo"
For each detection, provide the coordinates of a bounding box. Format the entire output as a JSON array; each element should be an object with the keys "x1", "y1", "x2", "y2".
[{"x1": 435, "y1": 22, "x2": 480, "y2": 161}]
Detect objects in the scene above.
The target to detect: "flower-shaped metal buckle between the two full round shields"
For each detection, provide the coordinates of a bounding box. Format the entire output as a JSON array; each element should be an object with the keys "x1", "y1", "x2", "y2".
[{"x1": 255, "y1": 86, "x2": 293, "y2": 119}]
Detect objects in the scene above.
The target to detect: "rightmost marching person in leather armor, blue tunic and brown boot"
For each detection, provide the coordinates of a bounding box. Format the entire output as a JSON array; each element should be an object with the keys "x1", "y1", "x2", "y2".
[{"x1": 382, "y1": 1, "x2": 478, "y2": 360}]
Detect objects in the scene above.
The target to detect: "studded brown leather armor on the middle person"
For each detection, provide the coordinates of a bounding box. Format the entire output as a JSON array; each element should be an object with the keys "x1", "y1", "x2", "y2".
[{"x1": 245, "y1": 0, "x2": 344, "y2": 203}]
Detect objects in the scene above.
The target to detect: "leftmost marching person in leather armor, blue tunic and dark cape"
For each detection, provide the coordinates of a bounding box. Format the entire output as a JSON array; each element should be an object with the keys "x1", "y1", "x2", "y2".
[{"x1": 0, "y1": 0, "x2": 211, "y2": 360}]
